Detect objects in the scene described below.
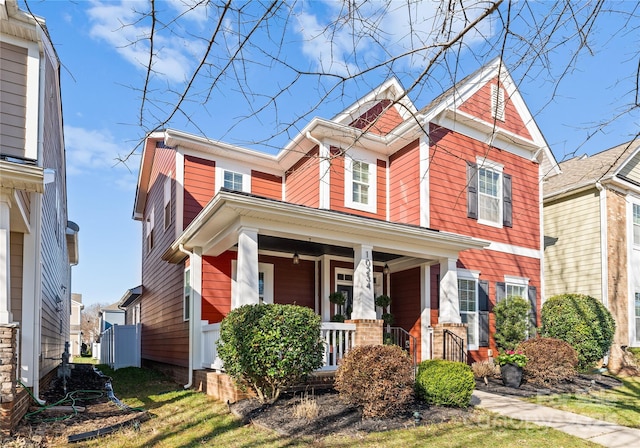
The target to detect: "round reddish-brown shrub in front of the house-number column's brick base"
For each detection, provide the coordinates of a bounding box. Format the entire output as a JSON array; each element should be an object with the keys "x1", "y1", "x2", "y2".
[{"x1": 335, "y1": 345, "x2": 414, "y2": 417}]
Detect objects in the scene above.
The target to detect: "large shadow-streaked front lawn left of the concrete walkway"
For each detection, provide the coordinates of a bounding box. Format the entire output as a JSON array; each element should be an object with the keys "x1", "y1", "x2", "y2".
[{"x1": 66, "y1": 366, "x2": 596, "y2": 448}]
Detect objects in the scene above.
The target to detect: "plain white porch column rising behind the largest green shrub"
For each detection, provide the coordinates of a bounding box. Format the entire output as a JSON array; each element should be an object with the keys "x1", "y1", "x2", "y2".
[{"x1": 232, "y1": 227, "x2": 260, "y2": 307}]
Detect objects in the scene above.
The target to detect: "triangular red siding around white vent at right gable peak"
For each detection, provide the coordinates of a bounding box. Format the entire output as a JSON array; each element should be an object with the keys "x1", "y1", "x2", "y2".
[{"x1": 460, "y1": 78, "x2": 531, "y2": 139}]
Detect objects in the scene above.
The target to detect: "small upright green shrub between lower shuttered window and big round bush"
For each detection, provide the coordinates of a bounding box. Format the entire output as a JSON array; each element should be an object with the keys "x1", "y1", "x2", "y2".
[{"x1": 493, "y1": 297, "x2": 531, "y2": 350}]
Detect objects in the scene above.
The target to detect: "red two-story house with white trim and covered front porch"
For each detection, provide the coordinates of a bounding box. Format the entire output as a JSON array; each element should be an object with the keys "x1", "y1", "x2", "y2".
[{"x1": 132, "y1": 60, "x2": 557, "y2": 383}]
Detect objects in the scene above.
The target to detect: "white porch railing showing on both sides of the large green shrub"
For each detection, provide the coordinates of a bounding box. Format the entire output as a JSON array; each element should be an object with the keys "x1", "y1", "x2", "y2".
[{"x1": 200, "y1": 321, "x2": 356, "y2": 371}]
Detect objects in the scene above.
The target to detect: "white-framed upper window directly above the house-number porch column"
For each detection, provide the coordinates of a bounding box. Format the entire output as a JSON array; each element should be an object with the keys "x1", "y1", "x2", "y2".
[{"x1": 345, "y1": 158, "x2": 376, "y2": 213}]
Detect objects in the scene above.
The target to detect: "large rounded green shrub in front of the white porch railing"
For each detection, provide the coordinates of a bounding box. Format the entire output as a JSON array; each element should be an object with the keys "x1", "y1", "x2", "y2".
[{"x1": 218, "y1": 304, "x2": 324, "y2": 403}]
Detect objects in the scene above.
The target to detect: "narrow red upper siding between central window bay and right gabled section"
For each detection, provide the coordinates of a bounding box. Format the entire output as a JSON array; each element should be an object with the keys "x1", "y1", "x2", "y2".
[{"x1": 389, "y1": 140, "x2": 420, "y2": 225}]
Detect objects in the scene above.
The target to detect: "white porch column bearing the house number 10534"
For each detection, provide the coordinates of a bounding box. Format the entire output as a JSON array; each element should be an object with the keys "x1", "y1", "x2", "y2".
[{"x1": 351, "y1": 245, "x2": 376, "y2": 320}]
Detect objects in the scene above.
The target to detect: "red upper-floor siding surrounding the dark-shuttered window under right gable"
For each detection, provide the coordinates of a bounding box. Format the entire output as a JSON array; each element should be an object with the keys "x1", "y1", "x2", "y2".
[{"x1": 429, "y1": 125, "x2": 541, "y2": 249}]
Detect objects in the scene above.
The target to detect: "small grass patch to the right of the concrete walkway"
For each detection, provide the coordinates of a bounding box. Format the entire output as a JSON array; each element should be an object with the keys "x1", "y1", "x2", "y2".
[{"x1": 529, "y1": 378, "x2": 640, "y2": 428}]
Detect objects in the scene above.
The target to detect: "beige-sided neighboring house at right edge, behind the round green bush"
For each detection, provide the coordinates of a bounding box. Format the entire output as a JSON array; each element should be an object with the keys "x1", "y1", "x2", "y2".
[{"x1": 544, "y1": 140, "x2": 640, "y2": 371}]
